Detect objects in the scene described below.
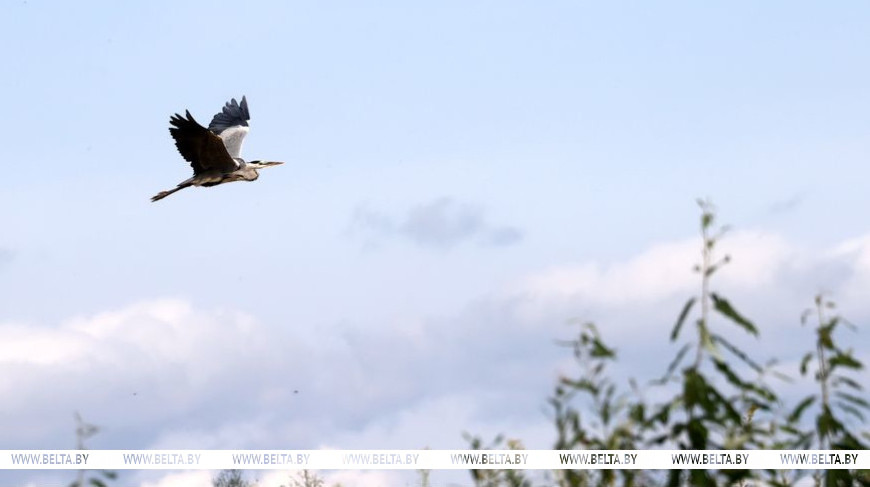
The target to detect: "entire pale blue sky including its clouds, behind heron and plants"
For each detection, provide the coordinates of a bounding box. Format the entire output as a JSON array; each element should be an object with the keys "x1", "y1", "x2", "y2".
[{"x1": 0, "y1": 0, "x2": 870, "y2": 487}]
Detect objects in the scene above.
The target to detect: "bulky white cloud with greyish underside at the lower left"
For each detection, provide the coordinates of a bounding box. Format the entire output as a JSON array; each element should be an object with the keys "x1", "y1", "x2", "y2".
[{"x1": 0, "y1": 299, "x2": 305, "y2": 448}]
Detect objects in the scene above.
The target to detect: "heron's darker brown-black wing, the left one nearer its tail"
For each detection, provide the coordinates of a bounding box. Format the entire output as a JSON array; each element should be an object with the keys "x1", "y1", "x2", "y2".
[{"x1": 169, "y1": 112, "x2": 239, "y2": 174}]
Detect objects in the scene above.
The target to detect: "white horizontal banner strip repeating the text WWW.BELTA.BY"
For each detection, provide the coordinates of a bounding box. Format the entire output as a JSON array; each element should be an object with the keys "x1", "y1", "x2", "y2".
[{"x1": 0, "y1": 450, "x2": 870, "y2": 470}]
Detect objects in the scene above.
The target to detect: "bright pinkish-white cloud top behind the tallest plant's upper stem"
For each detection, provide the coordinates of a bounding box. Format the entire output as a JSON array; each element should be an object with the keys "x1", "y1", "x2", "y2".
[{"x1": 515, "y1": 231, "x2": 870, "y2": 312}]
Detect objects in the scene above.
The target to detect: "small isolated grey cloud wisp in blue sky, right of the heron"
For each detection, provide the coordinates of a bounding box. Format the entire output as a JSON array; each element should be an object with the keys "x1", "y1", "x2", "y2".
[{"x1": 352, "y1": 198, "x2": 523, "y2": 249}]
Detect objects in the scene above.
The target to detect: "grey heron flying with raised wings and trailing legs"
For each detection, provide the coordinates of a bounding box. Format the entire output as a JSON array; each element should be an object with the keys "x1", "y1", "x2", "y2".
[{"x1": 151, "y1": 96, "x2": 283, "y2": 201}]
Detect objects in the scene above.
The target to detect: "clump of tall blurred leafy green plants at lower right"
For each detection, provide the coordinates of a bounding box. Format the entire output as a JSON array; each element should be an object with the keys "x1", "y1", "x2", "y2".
[{"x1": 466, "y1": 201, "x2": 870, "y2": 487}]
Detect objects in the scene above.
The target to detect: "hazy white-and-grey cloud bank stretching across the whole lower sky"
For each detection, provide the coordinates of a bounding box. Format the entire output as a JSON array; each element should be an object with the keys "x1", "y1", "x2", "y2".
[{"x1": 0, "y1": 231, "x2": 870, "y2": 487}]
